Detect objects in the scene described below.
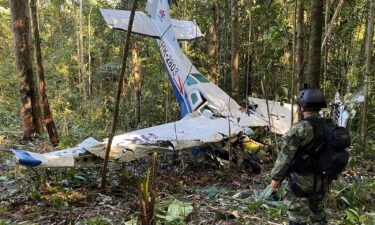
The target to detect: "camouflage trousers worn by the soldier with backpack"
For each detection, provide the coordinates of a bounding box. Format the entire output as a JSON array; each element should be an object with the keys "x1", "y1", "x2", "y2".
[{"x1": 284, "y1": 185, "x2": 327, "y2": 225}]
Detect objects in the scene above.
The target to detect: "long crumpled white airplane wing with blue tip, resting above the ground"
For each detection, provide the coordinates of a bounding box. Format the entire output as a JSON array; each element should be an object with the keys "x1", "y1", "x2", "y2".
[{"x1": 12, "y1": 111, "x2": 242, "y2": 167}]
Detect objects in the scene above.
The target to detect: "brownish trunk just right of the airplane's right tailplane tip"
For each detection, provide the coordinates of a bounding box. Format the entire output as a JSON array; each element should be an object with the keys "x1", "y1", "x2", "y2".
[{"x1": 208, "y1": 0, "x2": 220, "y2": 84}]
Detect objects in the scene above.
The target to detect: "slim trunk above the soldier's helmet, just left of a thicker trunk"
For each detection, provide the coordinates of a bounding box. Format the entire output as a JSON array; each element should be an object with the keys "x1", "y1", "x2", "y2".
[{"x1": 295, "y1": 0, "x2": 305, "y2": 91}]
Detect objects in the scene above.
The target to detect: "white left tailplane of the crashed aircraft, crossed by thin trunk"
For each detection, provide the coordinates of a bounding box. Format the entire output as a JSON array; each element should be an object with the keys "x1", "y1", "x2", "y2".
[{"x1": 100, "y1": 9, "x2": 160, "y2": 38}]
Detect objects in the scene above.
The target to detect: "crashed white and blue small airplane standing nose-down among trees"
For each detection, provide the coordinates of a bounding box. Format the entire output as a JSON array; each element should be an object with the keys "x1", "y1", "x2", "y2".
[{"x1": 12, "y1": 0, "x2": 358, "y2": 167}]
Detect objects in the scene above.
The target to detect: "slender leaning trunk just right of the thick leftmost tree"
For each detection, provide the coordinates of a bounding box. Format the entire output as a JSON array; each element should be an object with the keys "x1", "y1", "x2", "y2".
[{"x1": 30, "y1": 0, "x2": 58, "y2": 146}]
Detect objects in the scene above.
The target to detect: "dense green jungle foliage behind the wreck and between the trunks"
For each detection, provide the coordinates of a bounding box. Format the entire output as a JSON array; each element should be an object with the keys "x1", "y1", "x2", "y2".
[{"x1": 0, "y1": 0, "x2": 375, "y2": 224}]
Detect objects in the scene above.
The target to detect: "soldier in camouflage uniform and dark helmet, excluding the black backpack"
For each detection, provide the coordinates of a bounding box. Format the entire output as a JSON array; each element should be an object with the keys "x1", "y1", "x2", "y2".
[{"x1": 271, "y1": 89, "x2": 328, "y2": 225}]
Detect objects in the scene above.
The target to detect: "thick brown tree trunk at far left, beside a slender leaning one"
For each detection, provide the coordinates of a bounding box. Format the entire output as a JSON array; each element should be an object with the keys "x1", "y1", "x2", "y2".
[{"x1": 9, "y1": 0, "x2": 43, "y2": 140}]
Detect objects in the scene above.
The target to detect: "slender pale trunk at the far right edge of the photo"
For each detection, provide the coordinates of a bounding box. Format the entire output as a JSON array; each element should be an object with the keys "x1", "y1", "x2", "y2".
[{"x1": 361, "y1": 0, "x2": 375, "y2": 151}]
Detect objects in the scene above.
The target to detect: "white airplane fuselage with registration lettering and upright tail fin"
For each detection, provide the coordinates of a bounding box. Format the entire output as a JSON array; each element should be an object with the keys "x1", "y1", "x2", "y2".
[{"x1": 149, "y1": 0, "x2": 244, "y2": 117}]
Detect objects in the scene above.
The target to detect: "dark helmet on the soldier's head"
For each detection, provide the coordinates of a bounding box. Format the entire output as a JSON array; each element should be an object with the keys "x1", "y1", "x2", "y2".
[{"x1": 297, "y1": 89, "x2": 327, "y2": 110}]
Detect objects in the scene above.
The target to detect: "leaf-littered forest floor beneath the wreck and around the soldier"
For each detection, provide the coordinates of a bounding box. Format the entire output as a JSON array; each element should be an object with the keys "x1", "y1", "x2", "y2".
[{"x1": 0, "y1": 142, "x2": 375, "y2": 225}]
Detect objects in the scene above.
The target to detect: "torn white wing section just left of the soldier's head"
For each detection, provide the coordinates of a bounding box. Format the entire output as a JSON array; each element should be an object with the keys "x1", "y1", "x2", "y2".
[{"x1": 248, "y1": 97, "x2": 297, "y2": 134}]
